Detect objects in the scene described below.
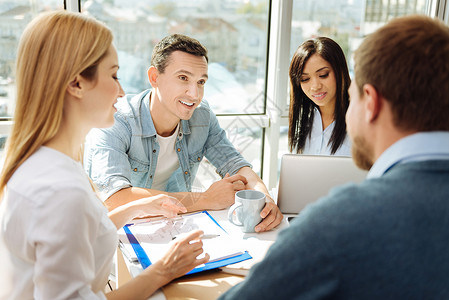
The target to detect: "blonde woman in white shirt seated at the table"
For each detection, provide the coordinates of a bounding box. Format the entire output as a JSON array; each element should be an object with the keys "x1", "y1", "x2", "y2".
[{"x1": 0, "y1": 11, "x2": 209, "y2": 299}]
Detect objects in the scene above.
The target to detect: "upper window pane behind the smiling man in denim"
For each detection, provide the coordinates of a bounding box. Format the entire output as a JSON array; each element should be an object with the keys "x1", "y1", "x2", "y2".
[{"x1": 81, "y1": 0, "x2": 269, "y2": 115}]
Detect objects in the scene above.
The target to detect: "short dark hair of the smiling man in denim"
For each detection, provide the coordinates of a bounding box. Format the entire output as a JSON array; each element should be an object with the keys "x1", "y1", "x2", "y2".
[{"x1": 151, "y1": 33, "x2": 209, "y2": 73}]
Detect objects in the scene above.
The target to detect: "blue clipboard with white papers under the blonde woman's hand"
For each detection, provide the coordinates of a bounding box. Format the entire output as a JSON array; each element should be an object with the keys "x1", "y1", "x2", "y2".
[{"x1": 119, "y1": 211, "x2": 251, "y2": 274}]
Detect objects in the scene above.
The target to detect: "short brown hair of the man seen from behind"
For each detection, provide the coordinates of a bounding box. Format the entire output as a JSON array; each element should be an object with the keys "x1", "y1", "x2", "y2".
[{"x1": 354, "y1": 16, "x2": 449, "y2": 131}]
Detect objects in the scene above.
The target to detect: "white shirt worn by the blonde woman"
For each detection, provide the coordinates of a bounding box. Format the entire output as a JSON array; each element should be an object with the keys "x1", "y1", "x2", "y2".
[{"x1": 0, "y1": 147, "x2": 118, "y2": 299}]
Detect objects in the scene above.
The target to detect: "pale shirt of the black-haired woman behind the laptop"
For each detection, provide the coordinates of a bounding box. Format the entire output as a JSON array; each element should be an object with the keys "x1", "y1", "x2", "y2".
[{"x1": 303, "y1": 108, "x2": 351, "y2": 156}]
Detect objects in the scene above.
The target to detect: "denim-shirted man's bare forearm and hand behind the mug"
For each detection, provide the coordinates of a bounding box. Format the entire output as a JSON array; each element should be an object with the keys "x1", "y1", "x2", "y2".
[{"x1": 237, "y1": 167, "x2": 283, "y2": 232}]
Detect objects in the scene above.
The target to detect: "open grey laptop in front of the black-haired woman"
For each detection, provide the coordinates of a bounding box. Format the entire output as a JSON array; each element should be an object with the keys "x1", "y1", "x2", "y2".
[{"x1": 277, "y1": 154, "x2": 368, "y2": 214}]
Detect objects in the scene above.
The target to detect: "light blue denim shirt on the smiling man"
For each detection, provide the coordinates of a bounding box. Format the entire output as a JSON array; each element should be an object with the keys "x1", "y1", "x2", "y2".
[{"x1": 84, "y1": 90, "x2": 252, "y2": 199}]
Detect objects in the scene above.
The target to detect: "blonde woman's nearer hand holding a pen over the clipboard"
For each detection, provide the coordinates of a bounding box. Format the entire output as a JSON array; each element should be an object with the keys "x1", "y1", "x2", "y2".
[{"x1": 144, "y1": 230, "x2": 209, "y2": 286}]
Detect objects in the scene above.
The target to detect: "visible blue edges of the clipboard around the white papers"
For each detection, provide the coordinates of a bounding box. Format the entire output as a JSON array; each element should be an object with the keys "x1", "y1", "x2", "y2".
[{"x1": 123, "y1": 211, "x2": 252, "y2": 275}]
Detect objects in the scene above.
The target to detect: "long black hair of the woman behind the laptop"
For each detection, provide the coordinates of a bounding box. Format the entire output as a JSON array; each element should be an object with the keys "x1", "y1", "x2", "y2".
[{"x1": 288, "y1": 37, "x2": 351, "y2": 154}]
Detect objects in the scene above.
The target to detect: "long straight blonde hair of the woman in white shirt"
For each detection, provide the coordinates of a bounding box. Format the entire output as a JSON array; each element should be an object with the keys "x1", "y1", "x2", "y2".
[{"x1": 0, "y1": 11, "x2": 112, "y2": 201}]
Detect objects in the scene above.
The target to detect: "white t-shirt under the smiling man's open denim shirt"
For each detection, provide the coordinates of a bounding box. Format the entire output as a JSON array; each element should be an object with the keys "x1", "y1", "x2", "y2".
[{"x1": 151, "y1": 124, "x2": 179, "y2": 191}]
